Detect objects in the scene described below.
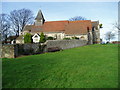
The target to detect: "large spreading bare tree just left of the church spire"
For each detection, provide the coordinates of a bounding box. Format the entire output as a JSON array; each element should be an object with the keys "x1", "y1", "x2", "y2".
[{"x1": 9, "y1": 8, "x2": 33, "y2": 36}]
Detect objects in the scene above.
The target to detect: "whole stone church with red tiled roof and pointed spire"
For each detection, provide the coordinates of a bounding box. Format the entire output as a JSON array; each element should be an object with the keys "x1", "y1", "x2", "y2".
[{"x1": 16, "y1": 10, "x2": 100, "y2": 43}]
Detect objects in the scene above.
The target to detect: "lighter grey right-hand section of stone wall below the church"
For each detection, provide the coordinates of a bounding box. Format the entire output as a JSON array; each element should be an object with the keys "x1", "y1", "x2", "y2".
[{"x1": 46, "y1": 40, "x2": 87, "y2": 49}]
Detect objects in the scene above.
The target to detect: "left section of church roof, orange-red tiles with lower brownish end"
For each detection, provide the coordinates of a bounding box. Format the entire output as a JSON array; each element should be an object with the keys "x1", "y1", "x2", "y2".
[{"x1": 24, "y1": 20, "x2": 68, "y2": 33}]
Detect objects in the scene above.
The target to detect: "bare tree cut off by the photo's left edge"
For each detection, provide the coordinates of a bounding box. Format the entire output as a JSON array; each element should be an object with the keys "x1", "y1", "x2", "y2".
[{"x1": 0, "y1": 14, "x2": 10, "y2": 41}]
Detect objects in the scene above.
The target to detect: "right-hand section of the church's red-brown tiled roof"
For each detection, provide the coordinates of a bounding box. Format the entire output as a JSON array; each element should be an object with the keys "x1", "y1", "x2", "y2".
[{"x1": 65, "y1": 20, "x2": 92, "y2": 35}]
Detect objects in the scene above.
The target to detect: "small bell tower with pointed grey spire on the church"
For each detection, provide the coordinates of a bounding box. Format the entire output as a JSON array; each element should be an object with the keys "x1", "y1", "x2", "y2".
[{"x1": 34, "y1": 10, "x2": 45, "y2": 26}]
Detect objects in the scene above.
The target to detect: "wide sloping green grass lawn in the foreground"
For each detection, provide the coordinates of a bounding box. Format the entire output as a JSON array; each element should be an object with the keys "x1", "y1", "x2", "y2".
[{"x1": 2, "y1": 44, "x2": 118, "y2": 88}]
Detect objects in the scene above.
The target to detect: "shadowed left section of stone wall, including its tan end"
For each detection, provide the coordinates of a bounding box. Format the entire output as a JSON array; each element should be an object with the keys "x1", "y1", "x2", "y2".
[{"x1": 1, "y1": 44, "x2": 46, "y2": 58}]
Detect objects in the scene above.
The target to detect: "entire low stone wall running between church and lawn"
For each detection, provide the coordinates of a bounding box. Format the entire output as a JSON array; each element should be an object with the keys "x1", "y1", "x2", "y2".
[{"x1": 1, "y1": 40, "x2": 87, "y2": 58}]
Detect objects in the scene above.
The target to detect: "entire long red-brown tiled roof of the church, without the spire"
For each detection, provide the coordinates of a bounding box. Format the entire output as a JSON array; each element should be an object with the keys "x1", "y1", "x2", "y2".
[{"x1": 24, "y1": 20, "x2": 92, "y2": 34}]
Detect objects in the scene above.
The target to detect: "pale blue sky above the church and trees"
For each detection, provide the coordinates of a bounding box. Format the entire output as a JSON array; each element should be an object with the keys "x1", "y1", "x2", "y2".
[{"x1": 2, "y1": 2, "x2": 118, "y2": 40}]
